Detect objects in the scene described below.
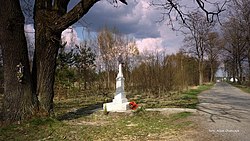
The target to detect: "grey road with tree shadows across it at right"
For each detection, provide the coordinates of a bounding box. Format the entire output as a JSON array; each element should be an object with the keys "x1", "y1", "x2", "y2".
[{"x1": 197, "y1": 82, "x2": 250, "y2": 141}]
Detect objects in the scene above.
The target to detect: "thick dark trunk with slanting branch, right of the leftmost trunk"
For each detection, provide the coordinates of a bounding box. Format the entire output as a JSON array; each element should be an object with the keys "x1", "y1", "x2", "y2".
[{"x1": 32, "y1": 0, "x2": 99, "y2": 115}]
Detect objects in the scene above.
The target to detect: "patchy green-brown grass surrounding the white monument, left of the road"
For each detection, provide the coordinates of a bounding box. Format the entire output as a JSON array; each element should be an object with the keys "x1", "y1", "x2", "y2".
[{"x1": 0, "y1": 84, "x2": 213, "y2": 141}]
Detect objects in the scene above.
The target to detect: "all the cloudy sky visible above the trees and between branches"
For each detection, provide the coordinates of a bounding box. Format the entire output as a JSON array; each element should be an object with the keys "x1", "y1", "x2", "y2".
[{"x1": 25, "y1": 0, "x2": 227, "y2": 54}]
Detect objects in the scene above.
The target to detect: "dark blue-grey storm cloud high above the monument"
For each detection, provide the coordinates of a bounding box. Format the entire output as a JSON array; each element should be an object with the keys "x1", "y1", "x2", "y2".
[{"x1": 77, "y1": 0, "x2": 160, "y2": 38}]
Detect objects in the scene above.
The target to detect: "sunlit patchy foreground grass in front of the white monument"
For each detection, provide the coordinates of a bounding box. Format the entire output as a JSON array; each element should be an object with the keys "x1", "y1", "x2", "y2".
[{"x1": 0, "y1": 112, "x2": 192, "y2": 141}]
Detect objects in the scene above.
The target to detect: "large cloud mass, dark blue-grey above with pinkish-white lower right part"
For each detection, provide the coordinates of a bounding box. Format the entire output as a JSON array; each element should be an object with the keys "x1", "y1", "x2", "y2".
[{"x1": 78, "y1": 0, "x2": 186, "y2": 54}]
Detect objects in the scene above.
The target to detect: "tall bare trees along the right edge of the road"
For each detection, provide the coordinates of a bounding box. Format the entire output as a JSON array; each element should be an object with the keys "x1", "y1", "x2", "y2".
[{"x1": 221, "y1": 0, "x2": 250, "y2": 86}]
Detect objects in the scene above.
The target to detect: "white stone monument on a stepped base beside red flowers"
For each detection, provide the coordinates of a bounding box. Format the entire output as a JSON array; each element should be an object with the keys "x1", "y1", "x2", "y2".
[{"x1": 103, "y1": 64, "x2": 129, "y2": 112}]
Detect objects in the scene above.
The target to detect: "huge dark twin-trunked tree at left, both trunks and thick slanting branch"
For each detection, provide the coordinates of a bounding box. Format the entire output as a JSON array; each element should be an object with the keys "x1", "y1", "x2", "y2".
[{"x1": 0, "y1": 0, "x2": 126, "y2": 121}]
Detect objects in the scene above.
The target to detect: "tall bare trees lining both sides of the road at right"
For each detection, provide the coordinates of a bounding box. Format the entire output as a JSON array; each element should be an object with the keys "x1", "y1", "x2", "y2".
[{"x1": 178, "y1": 0, "x2": 250, "y2": 85}]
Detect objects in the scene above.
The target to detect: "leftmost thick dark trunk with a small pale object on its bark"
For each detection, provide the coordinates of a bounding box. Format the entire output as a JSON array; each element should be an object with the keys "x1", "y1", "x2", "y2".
[{"x1": 0, "y1": 0, "x2": 37, "y2": 122}]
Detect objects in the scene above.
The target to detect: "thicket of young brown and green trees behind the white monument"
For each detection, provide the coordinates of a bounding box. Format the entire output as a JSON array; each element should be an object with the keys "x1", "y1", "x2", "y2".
[{"x1": 53, "y1": 27, "x2": 218, "y2": 101}]
